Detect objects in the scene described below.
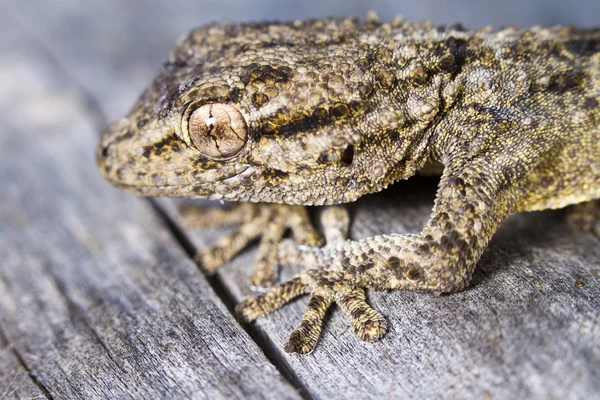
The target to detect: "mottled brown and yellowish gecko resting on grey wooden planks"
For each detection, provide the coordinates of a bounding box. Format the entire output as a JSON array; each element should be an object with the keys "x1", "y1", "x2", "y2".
[{"x1": 96, "y1": 13, "x2": 600, "y2": 354}]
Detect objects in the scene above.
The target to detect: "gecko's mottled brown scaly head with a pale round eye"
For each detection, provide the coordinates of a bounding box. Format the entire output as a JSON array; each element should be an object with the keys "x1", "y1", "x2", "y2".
[{"x1": 97, "y1": 20, "x2": 446, "y2": 205}]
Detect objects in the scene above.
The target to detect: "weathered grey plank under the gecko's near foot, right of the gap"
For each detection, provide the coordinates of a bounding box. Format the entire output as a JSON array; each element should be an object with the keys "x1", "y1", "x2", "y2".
[{"x1": 165, "y1": 182, "x2": 600, "y2": 399}]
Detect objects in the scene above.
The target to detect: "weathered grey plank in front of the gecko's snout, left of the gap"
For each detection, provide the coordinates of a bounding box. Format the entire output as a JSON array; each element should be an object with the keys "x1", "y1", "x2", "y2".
[{"x1": 0, "y1": 9, "x2": 299, "y2": 399}]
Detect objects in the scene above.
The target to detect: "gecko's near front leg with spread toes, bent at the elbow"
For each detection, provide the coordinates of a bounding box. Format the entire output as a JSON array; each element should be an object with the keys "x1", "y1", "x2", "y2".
[{"x1": 237, "y1": 160, "x2": 519, "y2": 354}]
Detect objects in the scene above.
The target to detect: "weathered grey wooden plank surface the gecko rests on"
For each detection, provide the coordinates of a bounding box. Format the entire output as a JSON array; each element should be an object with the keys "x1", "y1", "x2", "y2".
[{"x1": 0, "y1": 0, "x2": 600, "y2": 399}]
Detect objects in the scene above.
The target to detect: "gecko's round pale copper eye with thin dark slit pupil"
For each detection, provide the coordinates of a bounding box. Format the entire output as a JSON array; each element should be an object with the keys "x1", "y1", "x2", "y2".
[{"x1": 188, "y1": 104, "x2": 248, "y2": 160}]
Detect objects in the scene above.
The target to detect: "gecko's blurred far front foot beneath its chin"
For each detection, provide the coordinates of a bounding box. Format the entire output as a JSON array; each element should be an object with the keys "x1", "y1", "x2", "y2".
[{"x1": 179, "y1": 203, "x2": 322, "y2": 287}]
